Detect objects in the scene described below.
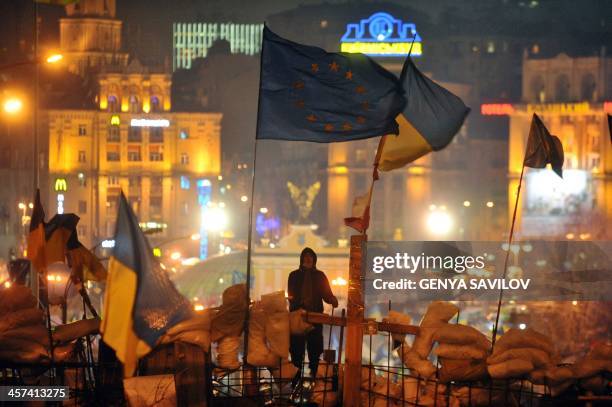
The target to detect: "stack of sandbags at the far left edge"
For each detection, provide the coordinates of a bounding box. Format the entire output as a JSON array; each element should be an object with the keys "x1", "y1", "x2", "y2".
[{"x1": 0, "y1": 285, "x2": 50, "y2": 363}]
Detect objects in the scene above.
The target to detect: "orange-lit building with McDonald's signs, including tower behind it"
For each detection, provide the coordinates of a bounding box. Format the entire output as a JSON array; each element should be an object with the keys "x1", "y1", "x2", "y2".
[{"x1": 42, "y1": 0, "x2": 222, "y2": 250}]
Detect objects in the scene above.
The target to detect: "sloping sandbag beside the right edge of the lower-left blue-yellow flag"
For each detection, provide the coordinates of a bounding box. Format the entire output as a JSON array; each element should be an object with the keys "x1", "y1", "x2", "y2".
[{"x1": 159, "y1": 308, "x2": 217, "y2": 353}]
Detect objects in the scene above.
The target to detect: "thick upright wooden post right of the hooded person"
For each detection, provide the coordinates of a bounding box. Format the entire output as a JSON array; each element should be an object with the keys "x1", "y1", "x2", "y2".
[{"x1": 342, "y1": 235, "x2": 367, "y2": 407}]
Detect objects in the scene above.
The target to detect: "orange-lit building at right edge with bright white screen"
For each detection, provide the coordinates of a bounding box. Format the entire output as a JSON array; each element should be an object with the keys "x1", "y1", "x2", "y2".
[{"x1": 505, "y1": 52, "x2": 612, "y2": 240}]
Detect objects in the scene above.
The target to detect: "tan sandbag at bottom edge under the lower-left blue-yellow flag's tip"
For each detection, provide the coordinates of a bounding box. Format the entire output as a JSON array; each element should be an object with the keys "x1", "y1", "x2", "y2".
[{"x1": 123, "y1": 374, "x2": 177, "y2": 407}]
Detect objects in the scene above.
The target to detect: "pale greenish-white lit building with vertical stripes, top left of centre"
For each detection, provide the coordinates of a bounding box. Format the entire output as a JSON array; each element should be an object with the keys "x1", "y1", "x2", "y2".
[{"x1": 172, "y1": 23, "x2": 263, "y2": 70}]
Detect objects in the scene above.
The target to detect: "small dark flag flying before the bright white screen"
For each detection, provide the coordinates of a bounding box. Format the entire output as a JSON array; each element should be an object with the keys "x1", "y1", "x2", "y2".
[{"x1": 523, "y1": 113, "x2": 564, "y2": 178}]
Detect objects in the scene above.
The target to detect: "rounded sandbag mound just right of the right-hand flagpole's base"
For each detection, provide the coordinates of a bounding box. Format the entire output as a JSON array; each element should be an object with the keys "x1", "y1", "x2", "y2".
[{"x1": 487, "y1": 328, "x2": 557, "y2": 379}]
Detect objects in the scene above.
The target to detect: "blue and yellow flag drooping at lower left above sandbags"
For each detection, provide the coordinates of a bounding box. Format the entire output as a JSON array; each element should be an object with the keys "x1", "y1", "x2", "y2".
[{"x1": 100, "y1": 193, "x2": 192, "y2": 377}]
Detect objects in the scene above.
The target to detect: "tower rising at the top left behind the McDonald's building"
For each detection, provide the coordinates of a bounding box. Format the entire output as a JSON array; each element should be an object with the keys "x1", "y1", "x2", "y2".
[{"x1": 60, "y1": 0, "x2": 128, "y2": 75}]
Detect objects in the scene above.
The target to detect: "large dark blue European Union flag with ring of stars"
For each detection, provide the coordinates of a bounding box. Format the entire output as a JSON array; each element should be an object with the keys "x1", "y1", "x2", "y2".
[{"x1": 257, "y1": 27, "x2": 406, "y2": 143}]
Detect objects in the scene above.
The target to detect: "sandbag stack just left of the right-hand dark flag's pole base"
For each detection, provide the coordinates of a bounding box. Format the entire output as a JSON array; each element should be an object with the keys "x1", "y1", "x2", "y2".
[{"x1": 432, "y1": 324, "x2": 491, "y2": 383}]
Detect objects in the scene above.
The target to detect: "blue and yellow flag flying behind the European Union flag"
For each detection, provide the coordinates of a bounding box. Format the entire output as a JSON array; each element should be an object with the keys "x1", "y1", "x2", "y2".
[{"x1": 378, "y1": 58, "x2": 470, "y2": 171}]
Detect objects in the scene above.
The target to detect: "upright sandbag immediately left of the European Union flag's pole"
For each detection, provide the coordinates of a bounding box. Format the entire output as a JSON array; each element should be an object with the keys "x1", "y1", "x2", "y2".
[{"x1": 211, "y1": 284, "x2": 247, "y2": 342}]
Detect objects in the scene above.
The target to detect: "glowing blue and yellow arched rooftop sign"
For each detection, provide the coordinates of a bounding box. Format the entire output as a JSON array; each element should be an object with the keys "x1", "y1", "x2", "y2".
[{"x1": 340, "y1": 12, "x2": 423, "y2": 57}]
